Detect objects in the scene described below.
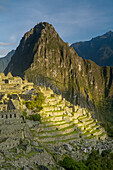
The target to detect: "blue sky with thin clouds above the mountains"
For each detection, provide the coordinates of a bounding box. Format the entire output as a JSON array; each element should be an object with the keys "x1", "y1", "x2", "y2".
[{"x1": 0, "y1": 0, "x2": 113, "y2": 57}]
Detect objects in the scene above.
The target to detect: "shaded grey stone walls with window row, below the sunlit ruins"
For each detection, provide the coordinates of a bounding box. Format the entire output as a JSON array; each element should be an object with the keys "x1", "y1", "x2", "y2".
[{"x1": 0, "y1": 110, "x2": 25, "y2": 150}]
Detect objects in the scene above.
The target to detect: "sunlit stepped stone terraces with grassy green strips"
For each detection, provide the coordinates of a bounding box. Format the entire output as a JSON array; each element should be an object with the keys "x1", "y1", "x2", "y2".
[{"x1": 36, "y1": 88, "x2": 107, "y2": 144}]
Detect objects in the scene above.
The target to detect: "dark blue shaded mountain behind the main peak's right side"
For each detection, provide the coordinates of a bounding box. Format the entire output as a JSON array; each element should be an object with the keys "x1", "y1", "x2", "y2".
[{"x1": 71, "y1": 31, "x2": 113, "y2": 66}]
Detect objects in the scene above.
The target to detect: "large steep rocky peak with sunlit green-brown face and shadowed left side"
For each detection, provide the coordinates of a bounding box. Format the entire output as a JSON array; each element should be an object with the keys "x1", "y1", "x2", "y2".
[{"x1": 5, "y1": 22, "x2": 113, "y2": 134}]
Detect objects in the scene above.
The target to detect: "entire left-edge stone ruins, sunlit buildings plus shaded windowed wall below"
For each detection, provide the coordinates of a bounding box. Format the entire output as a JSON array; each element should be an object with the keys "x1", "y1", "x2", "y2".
[{"x1": 0, "y1": 73, "x2": 33, "y2": 150}]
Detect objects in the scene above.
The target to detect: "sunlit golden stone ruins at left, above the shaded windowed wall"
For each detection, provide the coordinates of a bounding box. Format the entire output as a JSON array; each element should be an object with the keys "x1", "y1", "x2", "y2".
[{"x1": 0, "y1": 73, "x2": 34, "y2": 111}]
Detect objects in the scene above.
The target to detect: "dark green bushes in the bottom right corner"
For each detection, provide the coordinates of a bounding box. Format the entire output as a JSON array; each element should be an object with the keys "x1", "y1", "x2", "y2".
[{"x1": 59, "y1": 150, "x2": 113, "y2": 170}]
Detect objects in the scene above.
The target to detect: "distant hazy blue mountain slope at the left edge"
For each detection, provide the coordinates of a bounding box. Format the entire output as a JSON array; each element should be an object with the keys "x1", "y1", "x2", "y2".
[{"x1": 0, "y1": 50, "x2": 15, "y2": 72}]
